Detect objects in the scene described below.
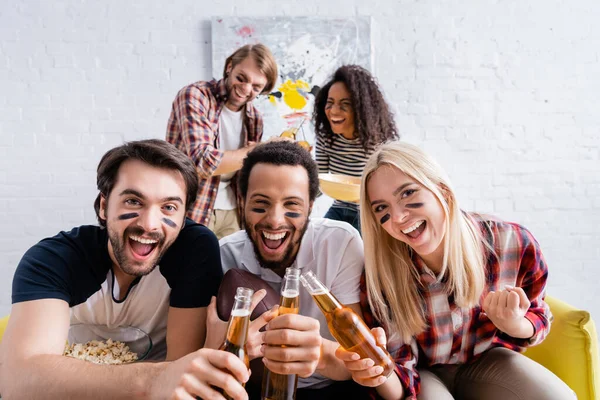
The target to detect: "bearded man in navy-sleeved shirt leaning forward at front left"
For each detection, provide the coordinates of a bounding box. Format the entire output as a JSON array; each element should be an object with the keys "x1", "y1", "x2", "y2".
[{"x1": 0, "y1": 140, "x2": 255, "y2": 400}]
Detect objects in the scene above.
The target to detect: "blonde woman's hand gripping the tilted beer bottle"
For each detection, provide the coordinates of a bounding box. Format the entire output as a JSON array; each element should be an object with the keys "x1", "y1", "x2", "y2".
[{"x1": 335, "y1": 328, "x2": 387, "y2": 387}]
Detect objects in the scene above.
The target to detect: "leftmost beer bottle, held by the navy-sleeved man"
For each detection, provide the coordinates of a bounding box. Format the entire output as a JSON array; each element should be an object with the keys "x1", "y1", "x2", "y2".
[{"x1": 217, "y1": 287, "x2": 254, "y2": 400}]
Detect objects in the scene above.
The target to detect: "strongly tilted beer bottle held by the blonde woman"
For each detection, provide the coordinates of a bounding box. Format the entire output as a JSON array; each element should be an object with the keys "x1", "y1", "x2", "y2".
[{"x1": 300, "y1": 271, "x2": 394, "y2": 377}]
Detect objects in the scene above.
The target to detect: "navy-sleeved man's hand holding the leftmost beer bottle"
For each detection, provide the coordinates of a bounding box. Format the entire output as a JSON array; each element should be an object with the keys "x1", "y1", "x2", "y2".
[{"x1": 151, "y1": 349, "x2": 250, "y2": 400}]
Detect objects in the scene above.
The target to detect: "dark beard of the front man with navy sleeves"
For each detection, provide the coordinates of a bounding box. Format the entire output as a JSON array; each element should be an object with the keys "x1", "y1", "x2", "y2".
[{"x1": 107, "y1": 224, "x2": 170, "y2": 277}]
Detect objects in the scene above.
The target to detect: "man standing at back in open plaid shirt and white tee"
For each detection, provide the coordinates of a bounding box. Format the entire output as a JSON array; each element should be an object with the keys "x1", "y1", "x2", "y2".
[{"x1": 166, "y1": 44, "x2": 277, "y2": 238}]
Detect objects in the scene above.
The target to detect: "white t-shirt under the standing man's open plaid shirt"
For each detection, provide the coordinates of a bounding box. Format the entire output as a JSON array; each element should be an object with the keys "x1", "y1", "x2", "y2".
[{"x1": 214, "y1": 106, "x2": 245, "y2": 210}]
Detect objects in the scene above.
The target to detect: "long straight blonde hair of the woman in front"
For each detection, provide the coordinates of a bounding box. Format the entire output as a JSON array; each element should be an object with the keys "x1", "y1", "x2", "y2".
[{"x1": 360, "y1": 141, "x2": 485, "y2": 343}]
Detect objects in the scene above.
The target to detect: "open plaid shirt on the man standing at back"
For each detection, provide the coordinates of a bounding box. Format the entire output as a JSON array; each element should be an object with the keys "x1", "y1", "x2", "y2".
[{"x1": 166, "y1": 79, "x2": 263, "y2": 225}]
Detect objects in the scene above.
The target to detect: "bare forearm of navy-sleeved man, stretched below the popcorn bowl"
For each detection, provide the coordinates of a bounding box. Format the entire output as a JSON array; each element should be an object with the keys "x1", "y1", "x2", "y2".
[{"x1": 0, "y1": 355, "x2": 167, "y2": 400}]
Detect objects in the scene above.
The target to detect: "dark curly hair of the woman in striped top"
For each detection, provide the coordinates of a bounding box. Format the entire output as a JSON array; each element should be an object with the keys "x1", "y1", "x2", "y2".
[{"x1": 313, "y1": 65, "x2": 400, "y2": 151}]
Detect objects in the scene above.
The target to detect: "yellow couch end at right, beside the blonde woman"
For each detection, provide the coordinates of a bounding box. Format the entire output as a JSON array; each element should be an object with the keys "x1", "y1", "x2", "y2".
[{"x1": 525, "y1": 296, "x2": 600, "y2": 400}]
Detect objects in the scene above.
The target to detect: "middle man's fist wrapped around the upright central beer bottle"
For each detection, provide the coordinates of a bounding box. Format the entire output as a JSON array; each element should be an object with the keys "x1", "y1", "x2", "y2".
[{"x1": 261, "y1": 314, "x2": 322, "y2": 378}]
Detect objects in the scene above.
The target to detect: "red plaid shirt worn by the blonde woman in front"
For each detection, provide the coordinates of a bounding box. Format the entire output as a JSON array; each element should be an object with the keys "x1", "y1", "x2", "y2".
[{"x1": 360, "y1": 214, "x2": 552, "y2": 399}]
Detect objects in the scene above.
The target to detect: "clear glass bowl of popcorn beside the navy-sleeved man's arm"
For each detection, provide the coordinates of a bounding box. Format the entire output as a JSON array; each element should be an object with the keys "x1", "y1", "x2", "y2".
[{"x1": 63, "y1": 324, "x2": 152, "y2": 364}]
